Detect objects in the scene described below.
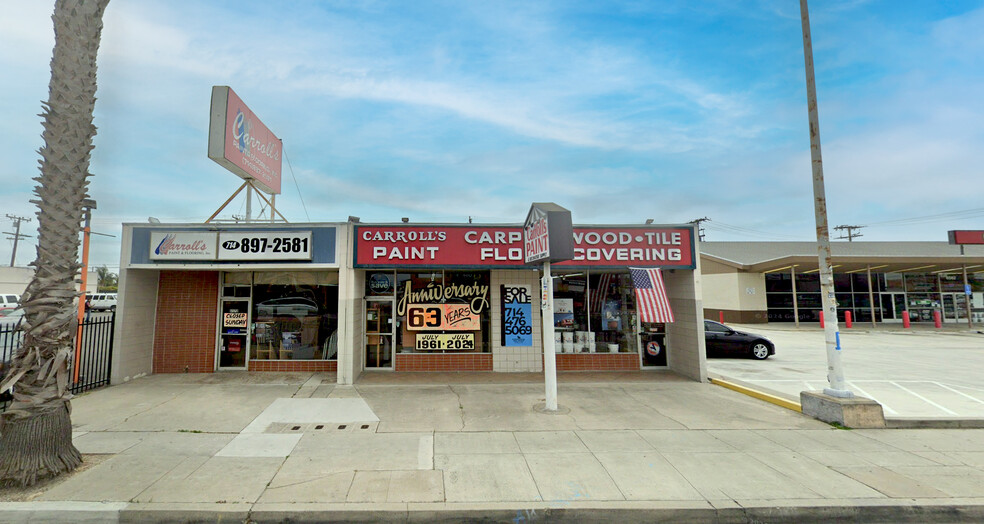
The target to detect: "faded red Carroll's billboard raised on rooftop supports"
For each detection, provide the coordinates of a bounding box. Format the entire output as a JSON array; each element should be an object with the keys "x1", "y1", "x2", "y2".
[{"x1": 208, "y1": 86, "x2": 283, "y2": 195}]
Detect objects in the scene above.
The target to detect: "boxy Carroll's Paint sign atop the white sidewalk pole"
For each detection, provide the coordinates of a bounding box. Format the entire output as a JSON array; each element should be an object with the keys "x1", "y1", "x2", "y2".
[{"x1": 523, "y1": 203, "x2": 574, "y2": 264}]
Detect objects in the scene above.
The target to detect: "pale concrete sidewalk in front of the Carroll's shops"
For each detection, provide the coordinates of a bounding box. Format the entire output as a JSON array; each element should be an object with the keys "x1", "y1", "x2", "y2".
[{"x1": 0, "y1": 372, "x2": 984, "y2": 522}]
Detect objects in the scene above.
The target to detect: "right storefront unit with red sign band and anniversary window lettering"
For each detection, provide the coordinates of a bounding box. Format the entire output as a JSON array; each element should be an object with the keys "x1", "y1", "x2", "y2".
[{"x1": 352, "y1": 224, "x2": 705, "y2": 380}]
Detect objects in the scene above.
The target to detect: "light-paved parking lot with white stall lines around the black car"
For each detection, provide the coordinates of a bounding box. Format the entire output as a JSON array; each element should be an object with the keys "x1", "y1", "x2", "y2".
[{"x1": 707, "y1": 324, "x2": 984, "y2": 419}]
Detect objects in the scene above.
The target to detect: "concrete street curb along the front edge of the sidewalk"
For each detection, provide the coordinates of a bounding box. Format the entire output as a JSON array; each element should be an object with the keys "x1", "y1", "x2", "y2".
[{"x1": 0, "y1": 499, "x2": 984, "y2": 524}]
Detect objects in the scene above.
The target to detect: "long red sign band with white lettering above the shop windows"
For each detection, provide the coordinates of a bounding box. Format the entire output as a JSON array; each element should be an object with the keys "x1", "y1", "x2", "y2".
[{"x1": 354, "y1": 225, "x2": 695, "y2": 269}]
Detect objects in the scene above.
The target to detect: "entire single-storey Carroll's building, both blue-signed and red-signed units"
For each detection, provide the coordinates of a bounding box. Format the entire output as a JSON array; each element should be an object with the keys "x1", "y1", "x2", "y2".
[{"x1": 112, "y1": 222, "x2": 706, "y2": 384}]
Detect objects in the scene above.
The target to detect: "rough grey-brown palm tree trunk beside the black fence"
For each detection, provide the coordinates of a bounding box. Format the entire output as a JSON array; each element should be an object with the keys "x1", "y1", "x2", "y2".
[{"x1": 0, "y1": 0, "x2": 109, "y2": 486}]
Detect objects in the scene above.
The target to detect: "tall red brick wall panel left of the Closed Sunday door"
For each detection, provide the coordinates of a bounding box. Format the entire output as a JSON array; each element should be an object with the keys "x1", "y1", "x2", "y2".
[{"x1": 154, "y1": 271, "x2": 219, "y2": 373}]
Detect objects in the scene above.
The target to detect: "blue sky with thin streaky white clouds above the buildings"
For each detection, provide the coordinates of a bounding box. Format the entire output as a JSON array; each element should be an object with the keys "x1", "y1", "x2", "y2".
[{"x1": 0, "y1": 0, "x2": 984, "y2": 272}]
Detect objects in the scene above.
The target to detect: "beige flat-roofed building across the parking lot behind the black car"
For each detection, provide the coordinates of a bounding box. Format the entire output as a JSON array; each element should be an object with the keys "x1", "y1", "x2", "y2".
[{"x1": 700, "y1": 242, "x2": 984, "y2": 324}]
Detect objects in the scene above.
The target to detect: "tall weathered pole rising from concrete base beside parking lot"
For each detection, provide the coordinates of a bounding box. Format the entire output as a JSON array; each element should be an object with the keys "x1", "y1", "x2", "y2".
[{"x1": 800, "y1": 0, "x2": 854, "y2": 398}]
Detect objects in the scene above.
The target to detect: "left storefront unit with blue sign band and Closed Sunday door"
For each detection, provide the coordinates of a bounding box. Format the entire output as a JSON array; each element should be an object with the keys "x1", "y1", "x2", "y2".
[{"x1": 111, "y1": 223, "x2": 351, "y2": 383}]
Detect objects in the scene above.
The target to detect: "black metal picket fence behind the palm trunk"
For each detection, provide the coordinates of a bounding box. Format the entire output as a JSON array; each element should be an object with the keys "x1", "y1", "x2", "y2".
[{"x1": 0, "y1": 311, "x2": 116, "y2": 411}]
